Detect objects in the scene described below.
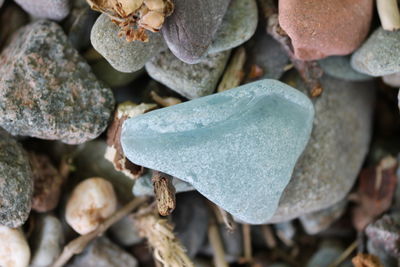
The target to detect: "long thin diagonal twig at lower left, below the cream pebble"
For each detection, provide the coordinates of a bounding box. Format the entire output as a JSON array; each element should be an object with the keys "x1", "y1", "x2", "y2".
[{"x1": 52, "y1": 197, "x2": 147, "y2": 267}]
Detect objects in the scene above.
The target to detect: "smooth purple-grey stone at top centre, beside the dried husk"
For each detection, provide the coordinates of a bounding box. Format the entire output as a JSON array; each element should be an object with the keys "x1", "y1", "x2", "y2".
[{"x1": 161, "y1": 0, "x2": 230, "y2": 64}]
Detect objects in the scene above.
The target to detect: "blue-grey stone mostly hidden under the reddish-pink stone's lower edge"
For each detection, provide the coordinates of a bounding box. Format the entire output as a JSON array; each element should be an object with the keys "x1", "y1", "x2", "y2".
[{"x1": 318, "y1": 56, "x2": 373, "y2": 82}]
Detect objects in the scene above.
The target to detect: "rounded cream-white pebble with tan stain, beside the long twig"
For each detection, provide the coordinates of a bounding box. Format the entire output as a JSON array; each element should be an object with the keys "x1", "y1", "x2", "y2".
[{"x1": 65, "y1": 178, "x2": 117, "y2": 235}]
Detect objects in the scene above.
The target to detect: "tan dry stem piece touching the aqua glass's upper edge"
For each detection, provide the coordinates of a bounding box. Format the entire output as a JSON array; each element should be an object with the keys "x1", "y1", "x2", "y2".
[{"x1": 217, "y1": 46, "x2": 246, "y2": 92}]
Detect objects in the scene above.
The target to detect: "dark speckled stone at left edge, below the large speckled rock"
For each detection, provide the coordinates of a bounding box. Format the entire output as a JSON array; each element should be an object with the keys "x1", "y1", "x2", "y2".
[{"x1": 0, "y1": 128, "x2": 33, "y2": 228}]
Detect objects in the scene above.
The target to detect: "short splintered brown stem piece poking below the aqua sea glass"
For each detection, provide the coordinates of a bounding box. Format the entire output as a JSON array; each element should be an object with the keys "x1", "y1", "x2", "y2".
[{"x1": 152, "y1": 171, "x2": 176, "y2": 216}]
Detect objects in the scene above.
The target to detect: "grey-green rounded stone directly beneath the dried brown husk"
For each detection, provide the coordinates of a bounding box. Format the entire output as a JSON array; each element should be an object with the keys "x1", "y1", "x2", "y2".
[{"x1": 90, "y1": 14, "x2": 166, "y2": 72}]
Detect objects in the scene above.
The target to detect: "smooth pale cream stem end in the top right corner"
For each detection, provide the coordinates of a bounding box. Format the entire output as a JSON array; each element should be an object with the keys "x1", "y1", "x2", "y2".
[{"x1": 376, "y1": 0, "x2": 400, "y2": 31}]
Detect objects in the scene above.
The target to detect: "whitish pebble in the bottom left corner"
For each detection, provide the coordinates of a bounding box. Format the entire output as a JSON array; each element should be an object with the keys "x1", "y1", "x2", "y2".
[{"x1": 0, "y1": 225, "x2": 31, "y2": 267}]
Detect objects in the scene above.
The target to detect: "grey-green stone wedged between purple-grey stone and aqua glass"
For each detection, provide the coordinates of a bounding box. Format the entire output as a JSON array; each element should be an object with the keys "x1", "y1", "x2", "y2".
[{"x1": 146, "y1": 51, "x2": 230, "y2": 99}]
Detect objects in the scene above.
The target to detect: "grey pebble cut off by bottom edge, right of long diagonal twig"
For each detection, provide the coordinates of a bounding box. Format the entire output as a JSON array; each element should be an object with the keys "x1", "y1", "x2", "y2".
[{"x1": 67, "y1": 237, "x2": 138, "y2": 267}]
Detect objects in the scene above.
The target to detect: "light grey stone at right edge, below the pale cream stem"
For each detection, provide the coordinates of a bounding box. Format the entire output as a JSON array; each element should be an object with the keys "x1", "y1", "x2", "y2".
[{"x1": 351, "y1": 27, "x2": 400, "y2": 76}]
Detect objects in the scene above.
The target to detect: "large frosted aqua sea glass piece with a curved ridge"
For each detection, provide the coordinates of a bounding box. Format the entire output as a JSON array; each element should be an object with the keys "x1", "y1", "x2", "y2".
[{"x1": 121, "y1": 80, "x2": 314, "y2": 224}]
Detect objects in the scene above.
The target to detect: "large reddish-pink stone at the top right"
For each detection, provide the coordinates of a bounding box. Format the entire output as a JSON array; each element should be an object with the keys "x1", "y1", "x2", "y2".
[{"x1": 279, "y1": 0, "x2": 374, "y2": 60}]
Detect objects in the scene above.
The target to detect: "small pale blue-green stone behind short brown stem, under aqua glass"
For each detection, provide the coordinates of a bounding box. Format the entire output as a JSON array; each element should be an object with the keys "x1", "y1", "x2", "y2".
[{"x1": 132, "y1": 171, "x2": 194, "y2": 196}]
